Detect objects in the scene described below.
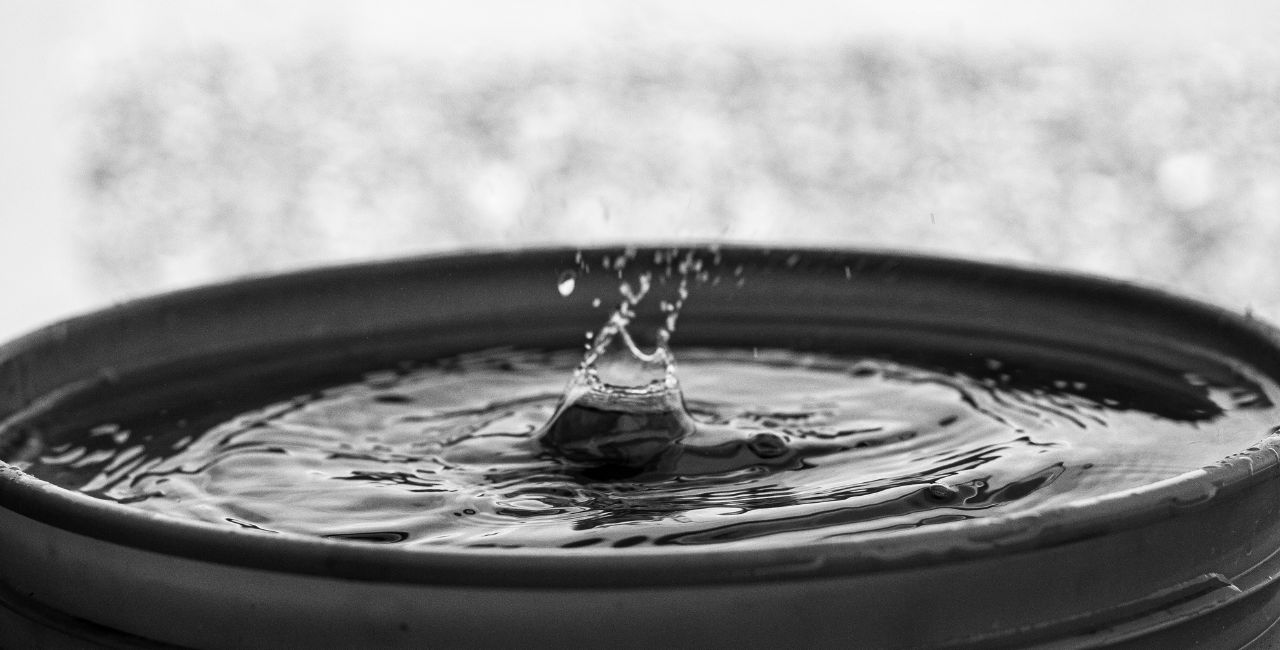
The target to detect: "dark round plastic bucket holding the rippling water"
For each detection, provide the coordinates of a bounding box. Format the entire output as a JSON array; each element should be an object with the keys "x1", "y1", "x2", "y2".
[{"x1": 0, "y1": 247, "x2": 1280, "y2": 647}]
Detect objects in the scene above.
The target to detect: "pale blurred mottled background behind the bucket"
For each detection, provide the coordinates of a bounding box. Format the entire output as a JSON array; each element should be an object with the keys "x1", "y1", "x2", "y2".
[{"x1": 0, "y1": 0, "x2": 1280, "y2": 340}]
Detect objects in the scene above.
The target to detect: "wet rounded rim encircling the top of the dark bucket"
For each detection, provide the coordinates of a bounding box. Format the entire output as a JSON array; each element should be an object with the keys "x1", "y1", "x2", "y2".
[{"x1": 0, "y1": 246, "x2": 1280, "y2": 587}]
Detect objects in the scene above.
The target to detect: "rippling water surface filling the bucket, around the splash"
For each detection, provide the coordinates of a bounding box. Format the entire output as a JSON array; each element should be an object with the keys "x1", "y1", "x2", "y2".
[{"x1": 12, "y1": 349, "x2": 1280, "y2": 549}]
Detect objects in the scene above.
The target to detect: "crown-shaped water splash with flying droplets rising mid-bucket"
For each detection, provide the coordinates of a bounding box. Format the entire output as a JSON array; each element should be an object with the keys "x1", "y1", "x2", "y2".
[{"x1": 538, "y1": 248, "x2": 875, "y2": 475}]
